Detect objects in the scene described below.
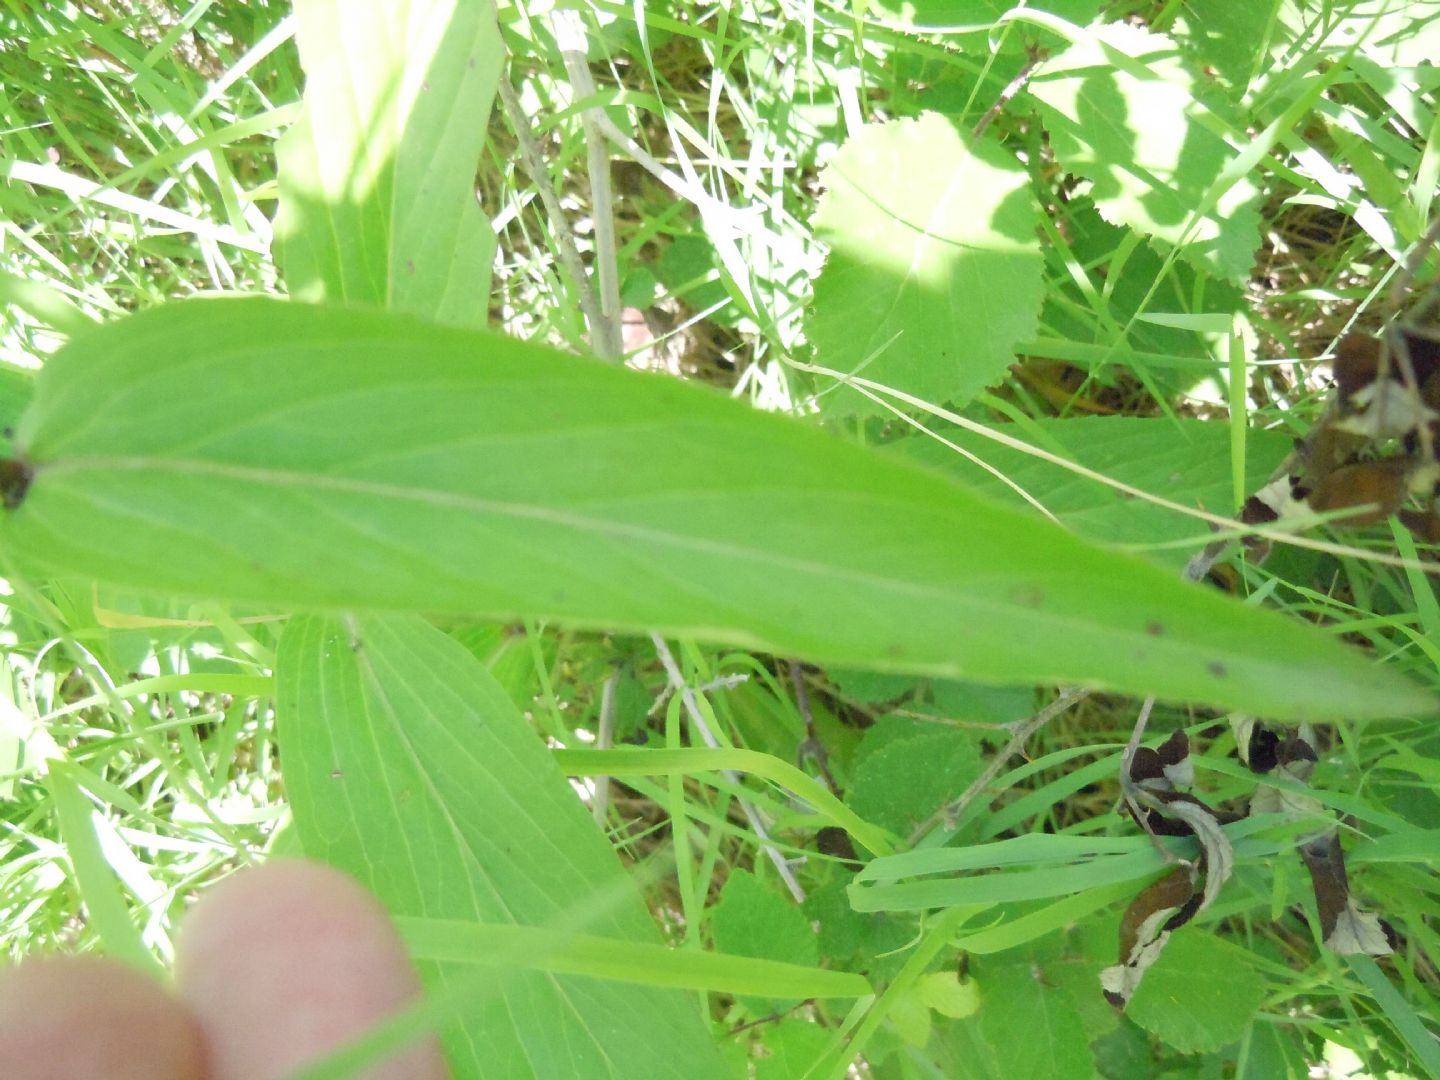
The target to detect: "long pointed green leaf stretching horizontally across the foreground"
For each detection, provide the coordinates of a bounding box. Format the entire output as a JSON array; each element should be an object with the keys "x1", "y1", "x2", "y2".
[{"x1": 0, "y1": 298, "x2": 1433, "y2": 719}]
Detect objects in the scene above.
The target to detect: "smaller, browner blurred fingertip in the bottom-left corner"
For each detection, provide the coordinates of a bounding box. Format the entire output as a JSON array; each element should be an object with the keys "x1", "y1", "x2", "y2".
[{"x1": 0, "y1": 956, "x2": 204, "y2": 1080}]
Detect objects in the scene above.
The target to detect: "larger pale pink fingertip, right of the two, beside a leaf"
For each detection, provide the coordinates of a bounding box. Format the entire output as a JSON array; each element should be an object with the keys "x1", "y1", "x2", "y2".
[{"x1": 176, "y1": 858, "x2": 449, "y2": 1080}]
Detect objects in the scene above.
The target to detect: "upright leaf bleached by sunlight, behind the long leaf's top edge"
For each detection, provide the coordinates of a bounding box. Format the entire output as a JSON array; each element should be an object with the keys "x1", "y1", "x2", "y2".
[{"x1": 276, "y1": 0, "x2": 501, "y2": 325}]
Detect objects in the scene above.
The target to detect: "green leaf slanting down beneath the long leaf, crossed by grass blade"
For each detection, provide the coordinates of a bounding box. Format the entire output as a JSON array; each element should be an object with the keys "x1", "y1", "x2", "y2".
[{"x1": 275, "y1": 616, "x2": 724, "y2": 1080}]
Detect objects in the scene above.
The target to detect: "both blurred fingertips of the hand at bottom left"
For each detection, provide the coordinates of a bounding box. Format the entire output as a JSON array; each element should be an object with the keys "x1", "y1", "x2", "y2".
[{"x1": 0, "y1": 860, "x2": 449, "y2": 1080}]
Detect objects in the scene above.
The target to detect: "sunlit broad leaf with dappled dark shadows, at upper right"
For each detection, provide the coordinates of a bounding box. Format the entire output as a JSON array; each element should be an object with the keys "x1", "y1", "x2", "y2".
[{"x1": 1028, "y1": 23, "x2": 1260, "y2": 282}]
